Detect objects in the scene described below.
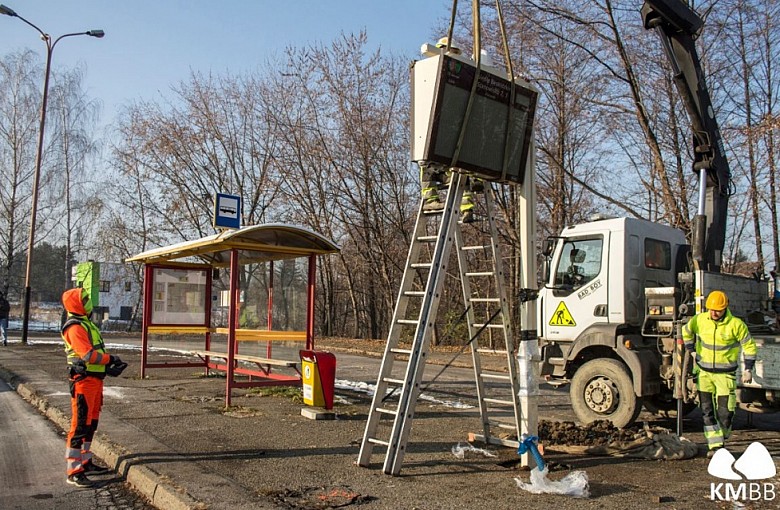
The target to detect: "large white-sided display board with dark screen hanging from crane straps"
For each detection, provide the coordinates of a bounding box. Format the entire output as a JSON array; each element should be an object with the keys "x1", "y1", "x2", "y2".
[{"x1": 412, "y1": 52, "x2": 538, "y2": 184}]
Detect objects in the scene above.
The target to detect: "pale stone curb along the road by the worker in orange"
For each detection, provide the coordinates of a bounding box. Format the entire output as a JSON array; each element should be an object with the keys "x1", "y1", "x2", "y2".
[{"x1": 0, "y1": 367, "x2": 206, "y2": 510}]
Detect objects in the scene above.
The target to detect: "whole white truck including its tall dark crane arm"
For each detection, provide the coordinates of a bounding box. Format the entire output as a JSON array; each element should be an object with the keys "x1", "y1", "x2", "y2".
[{"x1": 537, "y1": 0, "x2": 780, "y2": 428}]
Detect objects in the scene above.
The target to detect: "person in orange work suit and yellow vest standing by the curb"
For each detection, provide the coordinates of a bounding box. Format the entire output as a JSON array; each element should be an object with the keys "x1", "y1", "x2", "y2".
[{"x1": 62, "y1": 289, "x2": 127, "y2": 487}]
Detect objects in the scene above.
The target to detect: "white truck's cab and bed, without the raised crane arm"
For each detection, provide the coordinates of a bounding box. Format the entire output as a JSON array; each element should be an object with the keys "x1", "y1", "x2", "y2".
[{"x1": 537, "y1": 218, "x2": 780, "y2": 427}]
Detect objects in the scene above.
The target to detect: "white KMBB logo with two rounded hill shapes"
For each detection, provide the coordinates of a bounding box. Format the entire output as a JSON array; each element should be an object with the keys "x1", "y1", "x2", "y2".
[{"x1": 707, "y1": 442, "x2": 777, "y2": 501}]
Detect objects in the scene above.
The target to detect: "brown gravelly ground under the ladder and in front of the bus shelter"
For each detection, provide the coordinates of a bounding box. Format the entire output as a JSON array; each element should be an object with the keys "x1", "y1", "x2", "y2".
[{"x1": 1, "y1": 334, "x2": 780, "y2": 510}]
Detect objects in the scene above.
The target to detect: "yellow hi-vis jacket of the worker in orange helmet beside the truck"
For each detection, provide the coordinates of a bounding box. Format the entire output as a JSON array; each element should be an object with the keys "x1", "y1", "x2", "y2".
[{"x1": 683, "y1": 309, "x2": 756, "y2": 373}]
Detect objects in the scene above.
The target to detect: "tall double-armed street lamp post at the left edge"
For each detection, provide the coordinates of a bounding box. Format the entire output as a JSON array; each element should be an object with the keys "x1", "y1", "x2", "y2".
[{"x1": 0, "y1": 4, "x2": 105, "y2": 344}]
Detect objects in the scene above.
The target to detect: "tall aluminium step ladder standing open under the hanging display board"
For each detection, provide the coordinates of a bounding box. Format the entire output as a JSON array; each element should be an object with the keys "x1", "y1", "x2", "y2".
[{"x1": 357, "y1": 172, "x2": 520, "y2": 475}]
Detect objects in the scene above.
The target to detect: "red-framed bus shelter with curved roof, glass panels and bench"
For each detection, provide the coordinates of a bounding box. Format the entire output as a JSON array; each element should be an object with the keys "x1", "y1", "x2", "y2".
[{"x1": 126, "y1": 224, "x2": 339, "y2": 406}]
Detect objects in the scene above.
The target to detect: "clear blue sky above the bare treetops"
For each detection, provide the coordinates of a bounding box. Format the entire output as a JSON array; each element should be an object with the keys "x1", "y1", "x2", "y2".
[{"x1": 0, "y1": 0, "x2": 452, "y2": 133}]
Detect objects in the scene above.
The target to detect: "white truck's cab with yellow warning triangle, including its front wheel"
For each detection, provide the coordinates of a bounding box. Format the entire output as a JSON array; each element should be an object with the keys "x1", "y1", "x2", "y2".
[{"x1": 537, "y1": 218, "x2": 690, "y2": 426}]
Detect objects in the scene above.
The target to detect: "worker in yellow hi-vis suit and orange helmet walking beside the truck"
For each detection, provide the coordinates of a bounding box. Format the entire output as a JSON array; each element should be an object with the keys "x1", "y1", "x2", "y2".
[{"x1": 682, "y1": 290, "x2": 756, "y2": 457}]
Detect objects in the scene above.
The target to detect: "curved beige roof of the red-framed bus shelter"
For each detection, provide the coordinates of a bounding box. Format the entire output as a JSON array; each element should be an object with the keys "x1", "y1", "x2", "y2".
[{"x1": 126, "y1": 223, "x2": 341, "y2": 267}]
